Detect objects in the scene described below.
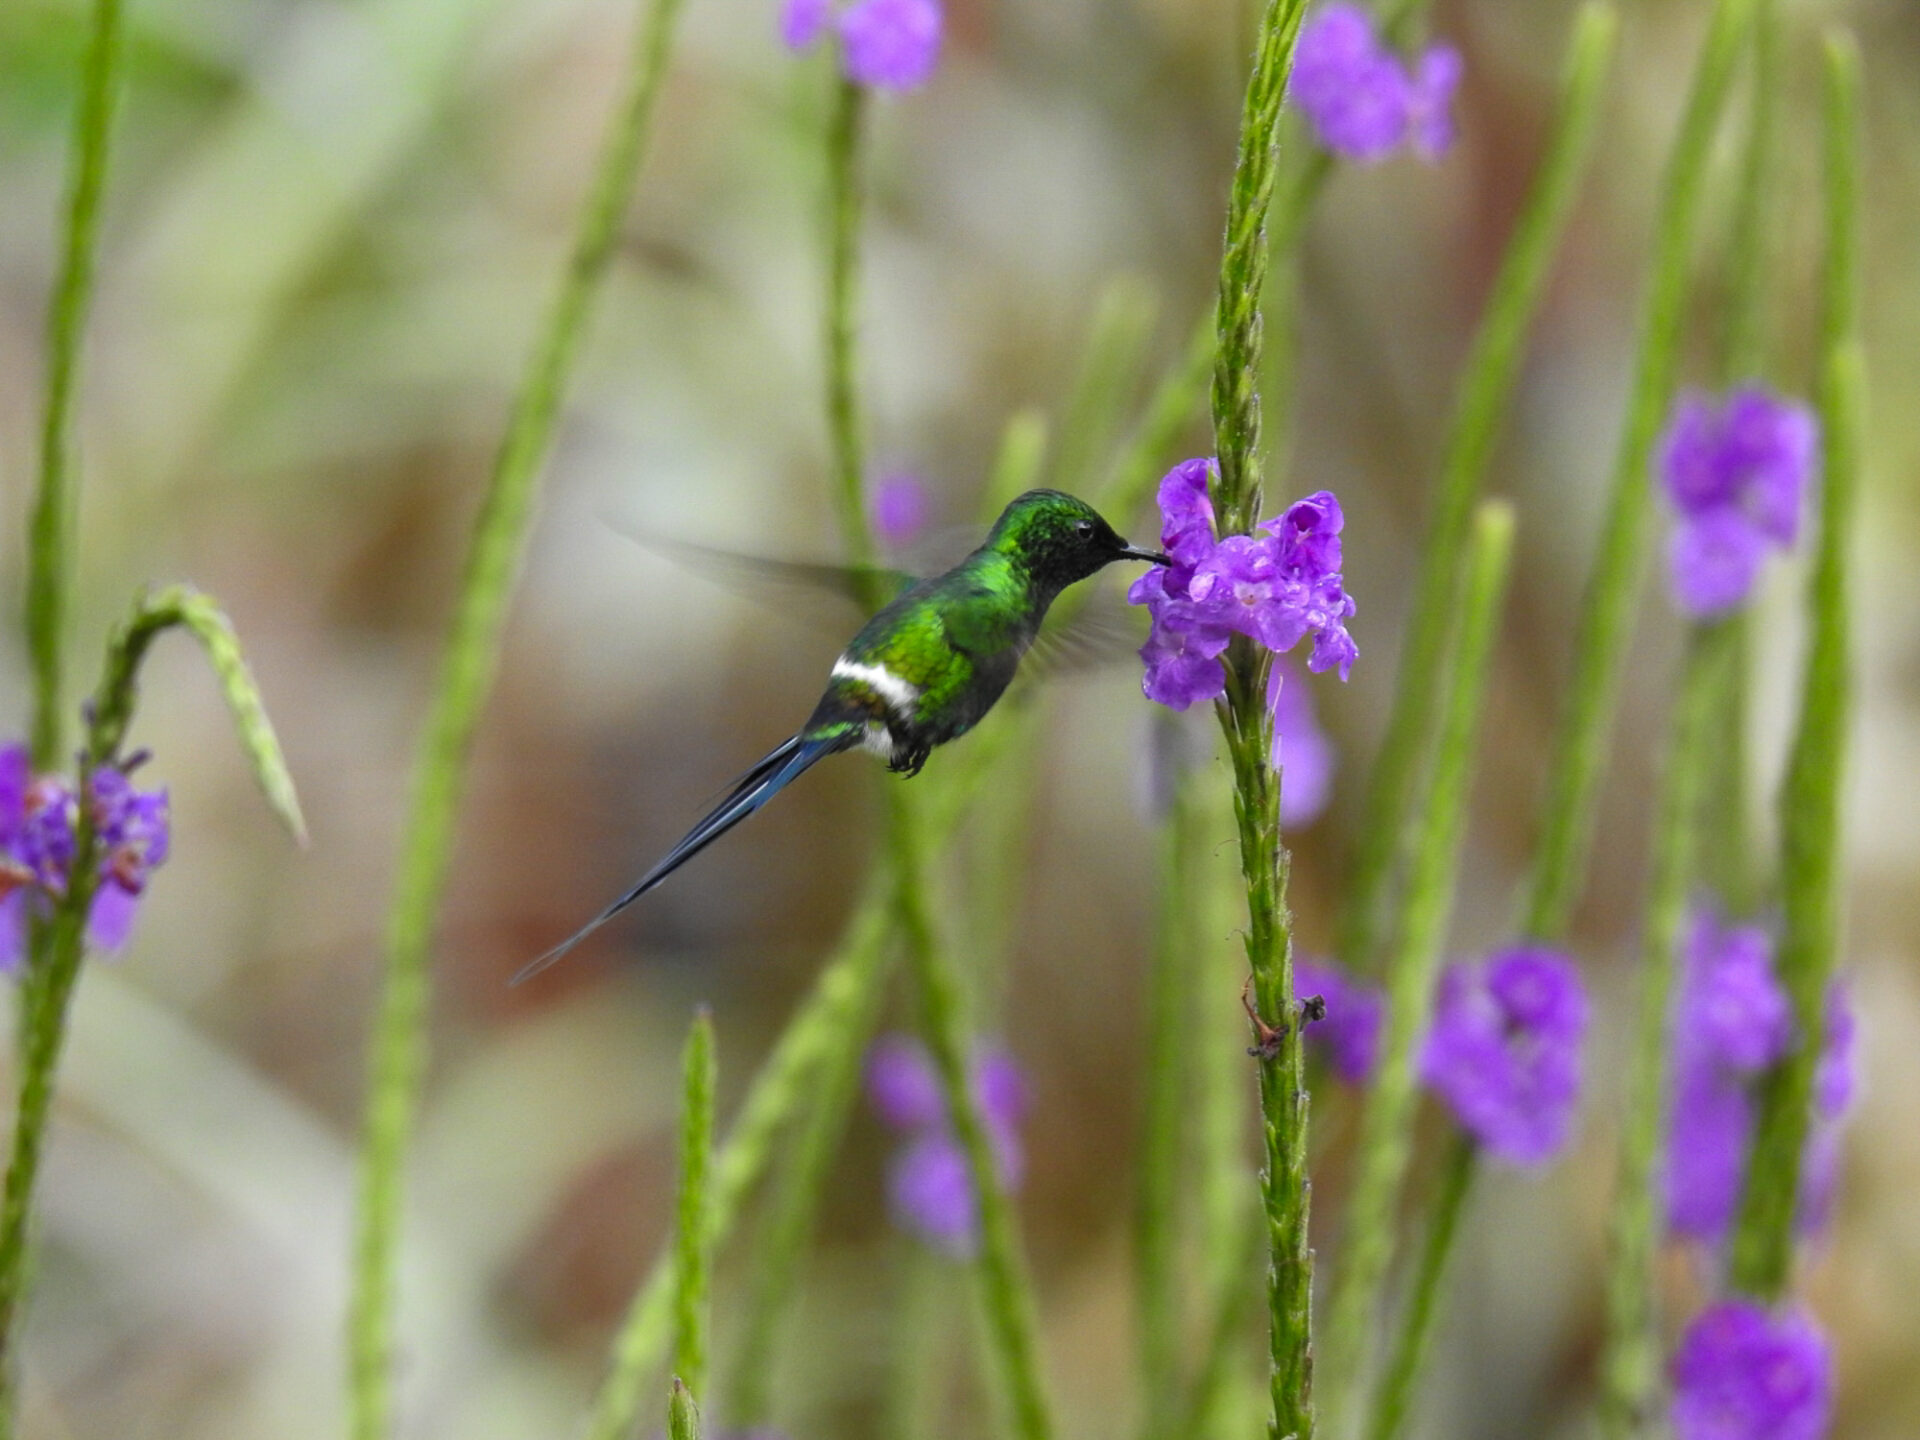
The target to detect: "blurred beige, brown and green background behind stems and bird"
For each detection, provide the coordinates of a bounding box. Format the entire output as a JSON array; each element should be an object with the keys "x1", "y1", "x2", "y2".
[{"x1": 0, "y1": 0, "x2": 1920, "y2": 1440}]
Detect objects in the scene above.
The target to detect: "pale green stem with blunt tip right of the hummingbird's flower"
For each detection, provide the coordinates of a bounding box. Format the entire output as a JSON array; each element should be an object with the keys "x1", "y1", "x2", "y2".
[{"x1": 1325, "y1": 501, "x2": 1513, "y2": 1419}]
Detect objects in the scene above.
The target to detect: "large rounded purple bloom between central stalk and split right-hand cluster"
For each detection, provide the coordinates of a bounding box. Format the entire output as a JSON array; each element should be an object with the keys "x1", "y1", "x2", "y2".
[{"x1": 1421, "y1": 947, "x2": 1588, "y2": 1165}]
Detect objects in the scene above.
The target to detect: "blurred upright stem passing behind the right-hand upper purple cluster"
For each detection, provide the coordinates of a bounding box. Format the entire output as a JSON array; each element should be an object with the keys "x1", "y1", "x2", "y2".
[{"x1": 1699, "y1": 0, "x2": 1780, "y2": 916}]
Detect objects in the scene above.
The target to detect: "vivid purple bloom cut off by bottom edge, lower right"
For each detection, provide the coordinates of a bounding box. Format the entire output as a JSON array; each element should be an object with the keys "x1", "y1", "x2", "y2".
[{"x1": 1672, "y1": 1300, "x2": 1834, "y2": 1440}]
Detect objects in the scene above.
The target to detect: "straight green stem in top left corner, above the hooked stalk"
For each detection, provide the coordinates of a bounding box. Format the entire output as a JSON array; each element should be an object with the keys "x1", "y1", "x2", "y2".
[{"x1": 27, "y1": 0, "x2": 125, "y2": 770}]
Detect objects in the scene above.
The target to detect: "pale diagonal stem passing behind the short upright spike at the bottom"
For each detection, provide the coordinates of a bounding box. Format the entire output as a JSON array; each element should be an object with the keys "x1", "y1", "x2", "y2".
[{"x1": 586, "y1": 872, "x2": 895, "y2": 1440}]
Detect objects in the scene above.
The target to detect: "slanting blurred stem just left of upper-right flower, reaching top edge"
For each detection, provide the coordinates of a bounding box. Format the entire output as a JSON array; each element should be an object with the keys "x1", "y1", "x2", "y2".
[{"x1": 1521, "y1": 0, "x2": 1755, "y2": 941}]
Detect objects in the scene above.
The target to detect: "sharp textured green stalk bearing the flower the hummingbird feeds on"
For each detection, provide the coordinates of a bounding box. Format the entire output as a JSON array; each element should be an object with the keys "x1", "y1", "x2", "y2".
[{"x1": 1212, "y1": 0, "x2": 1313, "y2": 1440}]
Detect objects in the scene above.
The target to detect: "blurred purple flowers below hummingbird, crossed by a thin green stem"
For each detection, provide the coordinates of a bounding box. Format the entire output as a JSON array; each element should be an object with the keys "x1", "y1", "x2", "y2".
[{"x1": 866, "y1": 1035, "x2": 1027, "y2": 1258}]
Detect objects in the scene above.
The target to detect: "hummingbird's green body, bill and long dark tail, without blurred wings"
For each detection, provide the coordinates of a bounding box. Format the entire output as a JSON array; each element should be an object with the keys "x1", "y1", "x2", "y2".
[{"x1": 513, "y1": 490, "x2": 1169, "y2": 985}]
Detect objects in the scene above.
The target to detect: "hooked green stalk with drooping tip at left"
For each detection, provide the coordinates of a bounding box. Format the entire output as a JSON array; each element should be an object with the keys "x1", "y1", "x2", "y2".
[{"x1": 0, "y1": 586, "x2": 305, "y2": 1436}]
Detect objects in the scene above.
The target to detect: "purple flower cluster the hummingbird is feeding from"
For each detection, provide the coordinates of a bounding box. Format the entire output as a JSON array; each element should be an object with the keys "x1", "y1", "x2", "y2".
[{"x1": 1127, "y1": 459, "x2": 1359, "y2": 710}]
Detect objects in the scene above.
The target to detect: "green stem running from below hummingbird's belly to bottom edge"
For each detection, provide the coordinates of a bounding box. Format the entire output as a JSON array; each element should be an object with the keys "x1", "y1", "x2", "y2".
[{"x1": 887, "y1": 785, "x2": 1052, "y2": 1440}]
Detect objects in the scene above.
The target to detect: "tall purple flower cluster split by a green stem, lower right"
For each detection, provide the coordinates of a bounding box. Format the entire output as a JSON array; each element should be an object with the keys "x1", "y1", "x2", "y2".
[{"x1": 1665, "y1": 908, "x2": 1853, "y2": 1244}]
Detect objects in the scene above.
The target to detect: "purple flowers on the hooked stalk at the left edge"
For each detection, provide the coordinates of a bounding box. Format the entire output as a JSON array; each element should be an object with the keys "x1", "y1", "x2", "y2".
[{"x1": 0, "y1": 745, "x2": 169, "y2": 973}]
